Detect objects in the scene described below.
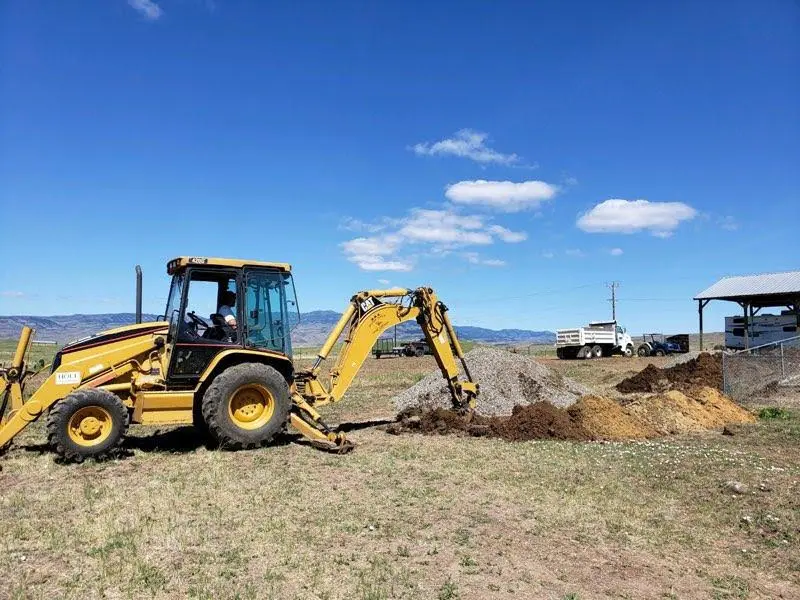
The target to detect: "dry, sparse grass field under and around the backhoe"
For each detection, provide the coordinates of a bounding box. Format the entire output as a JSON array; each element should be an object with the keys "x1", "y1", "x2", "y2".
[{"x1": 0, "y1": 350, "x2": 800, "y2": 600}]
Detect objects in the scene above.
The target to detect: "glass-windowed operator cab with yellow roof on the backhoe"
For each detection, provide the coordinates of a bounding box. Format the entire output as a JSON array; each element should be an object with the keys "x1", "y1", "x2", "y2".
[{"x1": 165, "y1": 257, "x2": 299, "y2": 384}]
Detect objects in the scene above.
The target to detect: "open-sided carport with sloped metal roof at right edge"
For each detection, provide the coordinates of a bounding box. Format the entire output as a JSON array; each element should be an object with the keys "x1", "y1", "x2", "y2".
[{"x1": 694, "y1": 271, "x2": 800, "y2": 350}]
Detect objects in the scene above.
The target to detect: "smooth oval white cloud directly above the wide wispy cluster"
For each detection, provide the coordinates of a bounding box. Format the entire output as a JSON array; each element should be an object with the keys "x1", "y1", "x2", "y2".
[{"x1": 445, "y1": 179, "x2": 559, "y2": 212}]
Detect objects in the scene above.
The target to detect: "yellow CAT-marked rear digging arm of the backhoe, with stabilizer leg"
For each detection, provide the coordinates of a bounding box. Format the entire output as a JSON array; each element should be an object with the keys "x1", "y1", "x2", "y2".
[{"x1": 291, "y1": 288, "x2": 478, "y2": 449}]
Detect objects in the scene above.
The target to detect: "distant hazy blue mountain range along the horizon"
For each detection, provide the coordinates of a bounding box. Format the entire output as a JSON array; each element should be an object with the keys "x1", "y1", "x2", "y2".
[{"x1": 0, "y1": 310, "x2": 555, "y2": 346}]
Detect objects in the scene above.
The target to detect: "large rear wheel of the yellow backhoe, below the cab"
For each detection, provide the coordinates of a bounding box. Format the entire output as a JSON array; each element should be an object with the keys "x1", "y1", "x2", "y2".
[{"x1": 203, "y1": 363, "x2": 291, "y2": 450}]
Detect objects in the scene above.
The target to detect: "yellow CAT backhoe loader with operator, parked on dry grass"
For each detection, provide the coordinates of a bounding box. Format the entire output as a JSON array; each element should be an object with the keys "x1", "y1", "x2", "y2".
[{"x1": 0, "y1": 257, "x2": 478, "y2": 461}]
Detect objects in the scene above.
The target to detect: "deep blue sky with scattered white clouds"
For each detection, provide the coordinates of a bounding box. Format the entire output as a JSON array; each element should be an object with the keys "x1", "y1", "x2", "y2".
[{"x1": 0, "y1": 0, "x2": 800, "y2": 332}]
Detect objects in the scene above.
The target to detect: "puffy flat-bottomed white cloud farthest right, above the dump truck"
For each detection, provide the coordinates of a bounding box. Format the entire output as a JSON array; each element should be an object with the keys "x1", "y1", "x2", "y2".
[{"x1": 577, "y1": 198, "x2": 697, "y2": 237}]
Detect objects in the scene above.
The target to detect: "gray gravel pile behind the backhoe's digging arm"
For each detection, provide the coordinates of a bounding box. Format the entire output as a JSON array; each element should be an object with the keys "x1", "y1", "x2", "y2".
[{"x1": 393, "y1": 346, "x2": 590, "y2": 415}]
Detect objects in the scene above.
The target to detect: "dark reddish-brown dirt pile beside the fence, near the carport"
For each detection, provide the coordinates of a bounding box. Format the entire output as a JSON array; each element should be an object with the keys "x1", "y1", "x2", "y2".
[{"x1": 616, "y1": 352, "x2": 722, "y2": 394}]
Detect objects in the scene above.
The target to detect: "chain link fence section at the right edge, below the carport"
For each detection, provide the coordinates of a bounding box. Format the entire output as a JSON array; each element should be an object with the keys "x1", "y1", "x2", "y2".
[{"x1": 722, "y1": 336, "x2": 800, "y2": 400}]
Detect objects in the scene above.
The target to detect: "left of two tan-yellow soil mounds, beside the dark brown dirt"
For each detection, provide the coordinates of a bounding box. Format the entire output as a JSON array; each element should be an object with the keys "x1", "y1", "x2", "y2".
[{"x1": 567, "y1": 396, "x2": 657, "y2": 440}]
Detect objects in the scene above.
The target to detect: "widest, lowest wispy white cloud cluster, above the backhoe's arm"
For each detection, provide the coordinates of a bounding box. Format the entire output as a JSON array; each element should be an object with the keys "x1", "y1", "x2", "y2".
[{"x1": 340, "y1": 208, "x2": 527, "y2": 271}]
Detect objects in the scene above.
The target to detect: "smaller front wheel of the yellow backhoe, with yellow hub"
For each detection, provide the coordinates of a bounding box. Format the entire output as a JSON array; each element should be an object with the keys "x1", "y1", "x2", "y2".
[{"x1": 47, "y1": 389, "x2": 128, "y2": 462}]
